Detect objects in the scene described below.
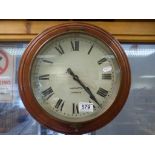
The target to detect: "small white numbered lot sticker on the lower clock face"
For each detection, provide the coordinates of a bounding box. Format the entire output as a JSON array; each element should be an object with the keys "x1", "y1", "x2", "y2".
[{"x1": 79, "y1": 102, "x2": 93, "y2": 112}]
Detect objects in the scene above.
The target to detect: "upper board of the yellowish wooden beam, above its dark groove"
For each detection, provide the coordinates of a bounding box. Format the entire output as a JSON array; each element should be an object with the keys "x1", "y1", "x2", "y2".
[{"x1": 0, "y1": 20, "x2": 155, "y2": 35}]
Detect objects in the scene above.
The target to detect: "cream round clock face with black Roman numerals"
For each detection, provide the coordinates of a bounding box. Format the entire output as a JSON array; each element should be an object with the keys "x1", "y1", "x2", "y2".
[{"x1": 30, "y1": 32, "x2": 121, "y2": 122}]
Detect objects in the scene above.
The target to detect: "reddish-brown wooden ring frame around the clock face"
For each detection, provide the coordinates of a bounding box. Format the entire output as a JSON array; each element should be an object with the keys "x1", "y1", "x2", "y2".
[{"x1": 18, "y1": 22, "x2": 131, "y2": 134}]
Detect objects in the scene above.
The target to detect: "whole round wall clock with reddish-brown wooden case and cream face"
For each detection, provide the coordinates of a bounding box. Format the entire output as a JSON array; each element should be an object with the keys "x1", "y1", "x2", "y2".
[{"x1": 18, "y1": 22, "x2": 130, "y2": 134}]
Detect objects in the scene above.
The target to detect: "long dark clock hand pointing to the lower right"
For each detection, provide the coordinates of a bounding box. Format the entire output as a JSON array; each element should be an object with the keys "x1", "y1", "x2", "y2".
[{"x1": 67, "y1": 68, "x2": 100, "y2": 106}]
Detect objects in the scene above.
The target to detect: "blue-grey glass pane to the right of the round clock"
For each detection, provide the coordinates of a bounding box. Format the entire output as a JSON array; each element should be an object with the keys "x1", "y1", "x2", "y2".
[{"x1": 96, "y1": 44, "x2": 155, "y2": 135}]
